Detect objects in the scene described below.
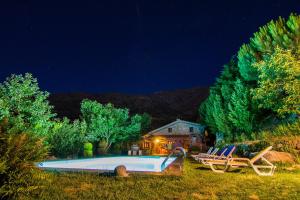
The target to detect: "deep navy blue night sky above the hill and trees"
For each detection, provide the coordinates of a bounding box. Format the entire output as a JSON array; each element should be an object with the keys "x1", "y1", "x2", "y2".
[{"x1": 0, "y1": 0, "x2": 300, "y2": 94}]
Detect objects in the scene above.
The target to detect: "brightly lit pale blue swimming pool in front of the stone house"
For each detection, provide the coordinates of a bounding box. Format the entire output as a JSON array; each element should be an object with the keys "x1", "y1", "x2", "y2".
[{"x1": 38, "y1": 156, "x2": 176, "y2": 172}]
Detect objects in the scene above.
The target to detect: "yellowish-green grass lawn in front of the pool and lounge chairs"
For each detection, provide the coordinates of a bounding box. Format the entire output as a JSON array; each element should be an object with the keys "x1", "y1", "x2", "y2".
[{"x1": 33, "y1": 159, "x2": 300, "y2": 200}]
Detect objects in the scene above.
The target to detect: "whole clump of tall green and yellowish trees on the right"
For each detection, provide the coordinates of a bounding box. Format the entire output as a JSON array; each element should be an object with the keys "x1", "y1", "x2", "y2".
[{"x1": 199, "y1": 14, "x2": 300, "y2": 142}]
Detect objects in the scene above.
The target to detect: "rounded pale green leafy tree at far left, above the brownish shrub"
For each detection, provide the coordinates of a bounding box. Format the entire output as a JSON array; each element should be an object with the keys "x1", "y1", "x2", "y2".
[{"x1": 0, "y1": 73, "x2": 55, "y2": 136}]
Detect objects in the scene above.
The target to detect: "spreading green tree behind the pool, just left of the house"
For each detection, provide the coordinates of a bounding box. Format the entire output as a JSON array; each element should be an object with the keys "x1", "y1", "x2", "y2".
[{"x1": 81, "y1": 100, "x2": 141, "y2": 151}]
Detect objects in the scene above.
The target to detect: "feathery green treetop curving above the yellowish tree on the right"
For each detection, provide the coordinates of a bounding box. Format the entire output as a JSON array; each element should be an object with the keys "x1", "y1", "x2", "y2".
[{"x1": 237, "y1": 14, "x2": 300, "y2": 81}]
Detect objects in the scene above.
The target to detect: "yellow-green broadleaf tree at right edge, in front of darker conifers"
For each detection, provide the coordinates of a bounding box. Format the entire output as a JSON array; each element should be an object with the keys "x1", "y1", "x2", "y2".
[{"x1": 253, "y1": 47, "x2": 300, "y2": 116}]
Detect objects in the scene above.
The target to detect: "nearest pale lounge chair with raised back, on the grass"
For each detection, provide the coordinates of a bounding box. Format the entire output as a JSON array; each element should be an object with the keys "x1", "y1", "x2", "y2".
[{"x1": 206, "y1": 146, "x2": 276, "y2": 176}]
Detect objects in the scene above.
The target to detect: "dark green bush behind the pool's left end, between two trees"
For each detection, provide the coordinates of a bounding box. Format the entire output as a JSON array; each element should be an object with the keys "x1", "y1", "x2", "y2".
[{"x1": 47, "y1": 118, "x2": 86, "y2": 158}]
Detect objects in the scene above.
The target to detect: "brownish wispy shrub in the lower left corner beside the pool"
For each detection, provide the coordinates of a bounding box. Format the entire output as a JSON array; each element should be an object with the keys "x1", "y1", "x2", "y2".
[{"x1": 0, "y1": 122, "x2": 49, "y2": 199}]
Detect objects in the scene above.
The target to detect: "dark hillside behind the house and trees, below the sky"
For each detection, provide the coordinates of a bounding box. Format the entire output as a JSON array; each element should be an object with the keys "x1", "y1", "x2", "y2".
[{"x1": 49, "y1": 87, "x2": 209, "y2": 128}]
